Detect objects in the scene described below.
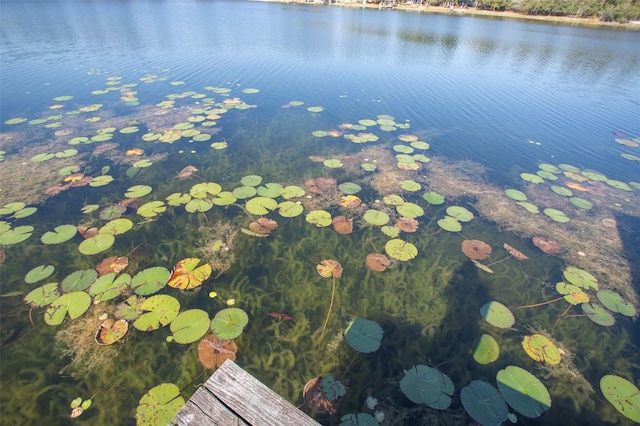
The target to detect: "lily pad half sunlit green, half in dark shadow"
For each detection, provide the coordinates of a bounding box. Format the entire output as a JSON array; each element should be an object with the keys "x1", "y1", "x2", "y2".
[{"x1": 496, "y1": 365, "x2": 551, "y2": 418}]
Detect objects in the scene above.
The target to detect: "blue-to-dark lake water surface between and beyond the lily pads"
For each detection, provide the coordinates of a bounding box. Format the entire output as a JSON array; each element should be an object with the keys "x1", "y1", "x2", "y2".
[{"x1": 0, "y1": 1, "x2": 640, "y2": 424}]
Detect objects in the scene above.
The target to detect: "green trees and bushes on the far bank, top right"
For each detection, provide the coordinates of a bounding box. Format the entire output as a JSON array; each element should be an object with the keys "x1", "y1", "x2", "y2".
[{"x1": 369, "y1": 0, "x2": 640, "y2": 23}]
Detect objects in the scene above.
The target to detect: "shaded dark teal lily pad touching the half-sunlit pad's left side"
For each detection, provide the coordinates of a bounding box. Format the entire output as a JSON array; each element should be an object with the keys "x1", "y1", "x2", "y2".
[{"x1": 460, "y1": 380, "x2": 509, "y2": 426}]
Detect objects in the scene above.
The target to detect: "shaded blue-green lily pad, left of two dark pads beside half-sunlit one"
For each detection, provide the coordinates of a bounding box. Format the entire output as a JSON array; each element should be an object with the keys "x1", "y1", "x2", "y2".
[{"x1": 400, "y1": 364, "x2": 454, "y2": 410}]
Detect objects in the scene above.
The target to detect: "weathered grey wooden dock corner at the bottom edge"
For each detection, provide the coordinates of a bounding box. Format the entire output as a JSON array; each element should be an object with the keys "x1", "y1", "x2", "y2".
[{"x1": 174, "y1": 360, "x2": 319, "y2": 426}]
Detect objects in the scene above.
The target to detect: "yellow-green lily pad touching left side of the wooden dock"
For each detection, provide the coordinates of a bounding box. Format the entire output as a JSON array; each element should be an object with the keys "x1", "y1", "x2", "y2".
[{"x1": 136, "y1": 383, "x2": 185, "y2": 426}]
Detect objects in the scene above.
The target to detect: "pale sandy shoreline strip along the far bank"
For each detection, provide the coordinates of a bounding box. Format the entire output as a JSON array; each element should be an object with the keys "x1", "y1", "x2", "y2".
[{"x1": 253, "y1": 0, "x2": 640, "y2": 31}]
